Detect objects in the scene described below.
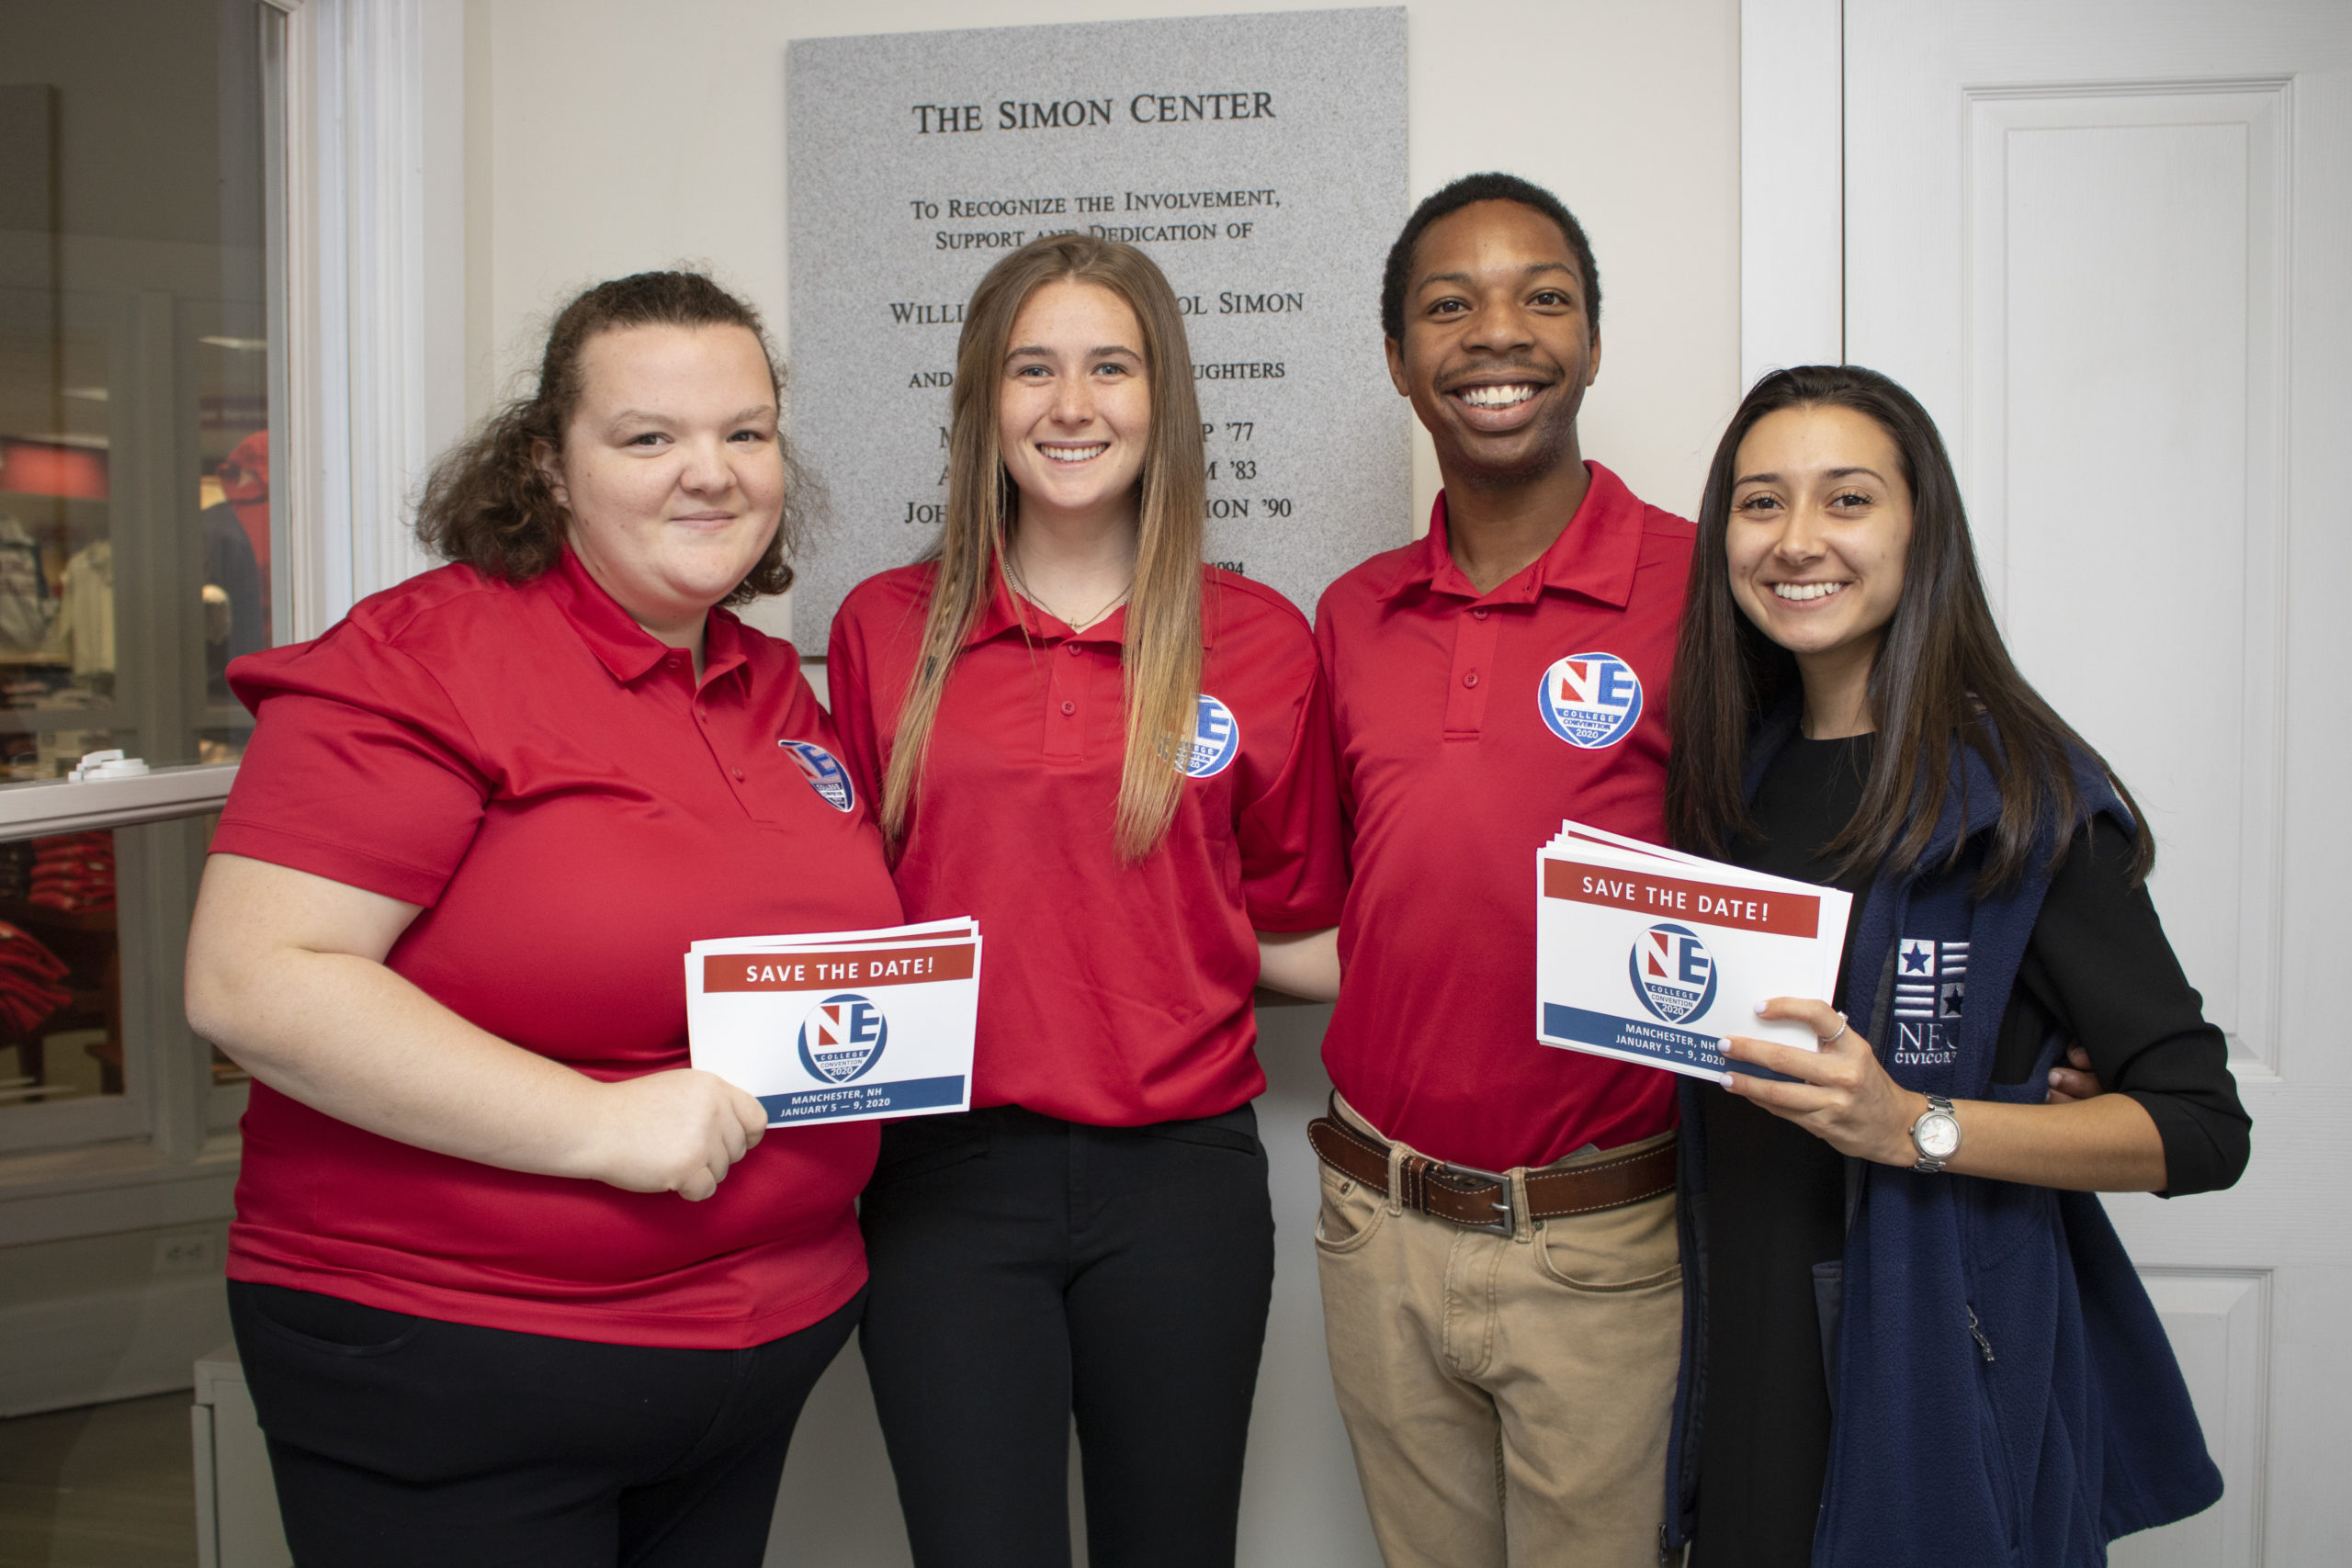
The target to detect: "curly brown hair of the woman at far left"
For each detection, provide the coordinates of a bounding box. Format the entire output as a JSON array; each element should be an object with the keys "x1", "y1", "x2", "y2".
[{"x1": 416, "y1": 273, "x2": 809, "y2": 604}]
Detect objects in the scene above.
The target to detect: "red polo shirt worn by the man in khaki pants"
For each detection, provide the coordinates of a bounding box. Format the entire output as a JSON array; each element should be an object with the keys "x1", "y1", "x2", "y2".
[{"x1": 1315, "y1": 463, "x2": 1693, "y2": 1170}]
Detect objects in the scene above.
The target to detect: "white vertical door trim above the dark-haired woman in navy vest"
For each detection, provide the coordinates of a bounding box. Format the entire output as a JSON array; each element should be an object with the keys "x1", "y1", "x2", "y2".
[{"x1": 1740, "y1": 0, "x2": 1847, "y2": 390}]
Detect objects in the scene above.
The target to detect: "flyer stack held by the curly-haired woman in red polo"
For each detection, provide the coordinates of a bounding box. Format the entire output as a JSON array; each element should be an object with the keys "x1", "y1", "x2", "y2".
[{"x1": 687, "y1": 919, "x2": 981, "y2": 1126}]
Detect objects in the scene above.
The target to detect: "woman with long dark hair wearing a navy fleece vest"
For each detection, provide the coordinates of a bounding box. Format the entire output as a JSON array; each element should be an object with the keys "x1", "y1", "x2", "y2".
[{"x1": 1668, "y1": 367, "x2": 2248, "y2": 1568}]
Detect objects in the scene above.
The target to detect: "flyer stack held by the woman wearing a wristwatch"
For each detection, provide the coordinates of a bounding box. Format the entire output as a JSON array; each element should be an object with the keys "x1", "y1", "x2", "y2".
[{"x1": 1536, "y1": 823, "x2": 1853, "y2": 1079}]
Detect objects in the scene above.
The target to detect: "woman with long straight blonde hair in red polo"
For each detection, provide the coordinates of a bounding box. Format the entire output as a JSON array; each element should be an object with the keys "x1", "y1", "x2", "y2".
[{"x1": 828, "y1": 235, "x2": 1343, "y2": 1568}]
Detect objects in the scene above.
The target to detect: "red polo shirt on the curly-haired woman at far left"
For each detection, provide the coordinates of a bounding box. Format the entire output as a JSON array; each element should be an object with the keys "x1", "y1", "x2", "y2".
[{"x1": 211, "y1": 552, "x2": 899, "y2": 1349}]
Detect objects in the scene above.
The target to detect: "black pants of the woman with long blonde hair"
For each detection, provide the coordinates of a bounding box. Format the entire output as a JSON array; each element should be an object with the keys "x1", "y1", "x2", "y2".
[{"x1": 858, "y1": 1105, "x2": 1275, "y2": 1568}]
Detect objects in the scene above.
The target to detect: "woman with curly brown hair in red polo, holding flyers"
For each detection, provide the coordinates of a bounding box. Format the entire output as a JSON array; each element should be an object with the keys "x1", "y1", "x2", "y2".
[{"x1": 188, "y1": 273, "x2": 899, "y2": 1568}]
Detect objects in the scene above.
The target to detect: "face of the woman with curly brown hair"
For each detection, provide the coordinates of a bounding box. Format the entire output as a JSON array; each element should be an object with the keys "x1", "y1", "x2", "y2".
[{"x1": 541, "y1": 327, "x2": 783, "y2": 647}]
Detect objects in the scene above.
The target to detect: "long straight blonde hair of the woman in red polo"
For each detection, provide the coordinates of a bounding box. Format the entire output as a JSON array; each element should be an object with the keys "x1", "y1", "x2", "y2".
[{"x1": 882, "y1": 235, "x2": 1209, "y2": 863}]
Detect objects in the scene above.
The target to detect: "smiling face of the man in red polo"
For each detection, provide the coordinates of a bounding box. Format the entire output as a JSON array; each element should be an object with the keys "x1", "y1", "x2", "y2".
[{"x1": 1387, "y1": 202, "x2": 1601, "y2": 484}]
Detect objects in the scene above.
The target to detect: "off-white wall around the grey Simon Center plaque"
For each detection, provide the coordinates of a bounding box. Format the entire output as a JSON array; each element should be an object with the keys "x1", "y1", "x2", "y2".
[{"x1": 468, "y1": 0, "x2": 1740, "y2": 557}]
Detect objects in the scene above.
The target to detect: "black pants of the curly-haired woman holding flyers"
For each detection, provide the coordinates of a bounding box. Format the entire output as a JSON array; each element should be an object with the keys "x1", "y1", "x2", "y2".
[{"x1": 228, "y1": 1281, "x2": 865, "y2": 1568}]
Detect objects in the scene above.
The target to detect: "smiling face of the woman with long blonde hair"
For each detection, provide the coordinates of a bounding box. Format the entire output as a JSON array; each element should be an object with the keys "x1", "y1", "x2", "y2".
[{"x1": 997, "y1": 280, "x2": 1152, "y2": 526}]
